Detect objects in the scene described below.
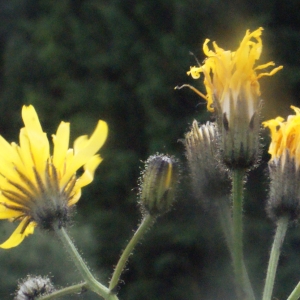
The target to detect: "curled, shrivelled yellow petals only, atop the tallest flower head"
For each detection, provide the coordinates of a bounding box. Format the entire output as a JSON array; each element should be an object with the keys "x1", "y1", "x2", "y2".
[{"x1": 187, "y1": 27, "x2": 282, "y2": 119}]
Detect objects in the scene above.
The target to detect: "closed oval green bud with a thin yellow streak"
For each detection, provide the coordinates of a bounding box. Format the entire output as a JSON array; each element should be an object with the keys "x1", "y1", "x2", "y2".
[{"x1": 140, "y1": 154, "x2": 179, "y2": 215}]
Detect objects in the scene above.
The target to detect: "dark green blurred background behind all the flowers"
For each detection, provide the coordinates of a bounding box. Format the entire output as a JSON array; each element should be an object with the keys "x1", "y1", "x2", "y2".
[{"x1": 0, "y1": 0, "x2": 300, "y2": 300}]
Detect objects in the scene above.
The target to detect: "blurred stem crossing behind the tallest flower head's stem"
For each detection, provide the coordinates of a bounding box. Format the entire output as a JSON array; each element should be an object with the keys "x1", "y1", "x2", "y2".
[{"x1": 218, "y1": 198, "x2": 255, "y2": 300}]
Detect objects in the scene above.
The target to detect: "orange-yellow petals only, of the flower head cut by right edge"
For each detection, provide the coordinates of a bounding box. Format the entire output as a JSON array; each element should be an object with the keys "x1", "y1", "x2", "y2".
[{"x1": 263, "y1": 106, "x2": 300, "y2": 169}]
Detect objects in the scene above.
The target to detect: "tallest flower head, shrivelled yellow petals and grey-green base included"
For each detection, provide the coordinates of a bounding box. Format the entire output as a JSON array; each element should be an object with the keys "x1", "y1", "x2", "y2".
[{"x1": 178, "y1": 27, "x2": 282, "y2": 169}]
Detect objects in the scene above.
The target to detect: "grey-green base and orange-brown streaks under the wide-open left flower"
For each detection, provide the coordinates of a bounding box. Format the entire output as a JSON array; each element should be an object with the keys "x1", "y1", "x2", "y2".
[{"x1": 1, "y1": 161, "x2": 76, "y2": 232}]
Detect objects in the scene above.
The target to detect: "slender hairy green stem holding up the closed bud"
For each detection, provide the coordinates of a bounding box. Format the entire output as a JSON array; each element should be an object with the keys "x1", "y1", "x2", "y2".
[{"x1": 109, "y1": 214, "x2": 155, "y2": 291}]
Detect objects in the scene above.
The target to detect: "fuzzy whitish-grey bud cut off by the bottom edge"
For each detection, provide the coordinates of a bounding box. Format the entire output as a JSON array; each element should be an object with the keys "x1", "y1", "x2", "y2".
[{"x1": 14, "y1": 276, "x2": 55, "y2": 300}]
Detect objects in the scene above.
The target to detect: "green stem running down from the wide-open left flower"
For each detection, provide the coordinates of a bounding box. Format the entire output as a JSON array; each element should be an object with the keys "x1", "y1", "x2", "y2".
[{"x1": 55, "y1": 227, "x2": 118, "y2": 300}]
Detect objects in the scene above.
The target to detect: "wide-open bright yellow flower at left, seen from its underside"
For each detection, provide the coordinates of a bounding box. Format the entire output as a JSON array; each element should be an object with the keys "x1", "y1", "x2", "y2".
[{"x1": 0, "y1": 105, "x2": 108, "y2": 249}]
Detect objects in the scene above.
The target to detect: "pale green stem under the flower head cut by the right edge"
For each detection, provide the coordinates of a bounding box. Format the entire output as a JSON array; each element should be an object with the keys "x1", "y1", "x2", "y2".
[{"x1": 262, "y1": 217, "x2": 289, "y2": 300}]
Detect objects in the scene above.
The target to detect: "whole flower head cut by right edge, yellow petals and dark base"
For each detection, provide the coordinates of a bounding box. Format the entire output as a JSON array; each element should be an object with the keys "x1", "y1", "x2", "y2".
[{"x1": 263, "y1": 106, "x2": 300, "y2": 220}]
